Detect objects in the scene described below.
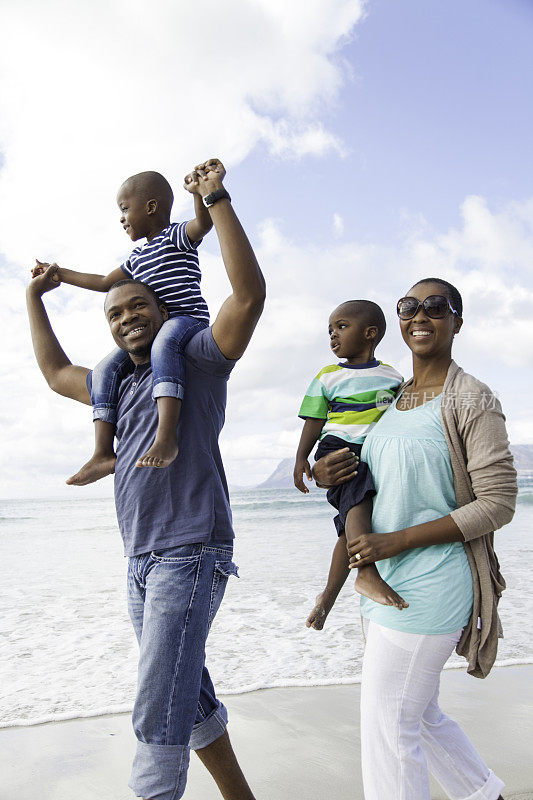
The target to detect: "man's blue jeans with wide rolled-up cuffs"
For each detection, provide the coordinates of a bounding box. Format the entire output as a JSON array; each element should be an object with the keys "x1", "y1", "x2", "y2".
[{"x1": 128, "y1": 542, "x2": 237, "y2": 800}]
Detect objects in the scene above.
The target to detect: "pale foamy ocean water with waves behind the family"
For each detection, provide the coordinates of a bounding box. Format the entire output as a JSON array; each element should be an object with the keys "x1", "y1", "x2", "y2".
[{"x1": 0, "y1": 488, "x2": 533, "y2": 727}]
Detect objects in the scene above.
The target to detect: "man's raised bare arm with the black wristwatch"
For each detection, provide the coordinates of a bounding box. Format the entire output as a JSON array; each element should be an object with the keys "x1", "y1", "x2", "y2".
[{"x1": 185, "y1": 158, "x2": 265, "y2": 359}]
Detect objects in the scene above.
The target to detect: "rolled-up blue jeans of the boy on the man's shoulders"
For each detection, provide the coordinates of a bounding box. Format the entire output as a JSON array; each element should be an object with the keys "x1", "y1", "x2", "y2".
[{"x1": 91, "y1": 316, "x2": 208, "y2": 424}]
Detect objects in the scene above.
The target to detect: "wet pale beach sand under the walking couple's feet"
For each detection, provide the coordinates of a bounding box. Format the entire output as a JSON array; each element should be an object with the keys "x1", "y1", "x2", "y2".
[{"x1": 0, "y1": 666, "x2": 533, "y2": 800}]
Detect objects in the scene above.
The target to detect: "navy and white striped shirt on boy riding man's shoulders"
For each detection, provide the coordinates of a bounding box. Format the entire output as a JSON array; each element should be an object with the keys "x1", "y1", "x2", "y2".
[{"x1": 121, "y1": 222, "x2": 209, "y2": 322}]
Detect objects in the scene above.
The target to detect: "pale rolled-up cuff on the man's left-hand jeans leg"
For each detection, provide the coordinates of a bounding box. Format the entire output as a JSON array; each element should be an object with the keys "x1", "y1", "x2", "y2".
[{"x1": 128, "y1": 741, "x2": 190, "y2": 800}]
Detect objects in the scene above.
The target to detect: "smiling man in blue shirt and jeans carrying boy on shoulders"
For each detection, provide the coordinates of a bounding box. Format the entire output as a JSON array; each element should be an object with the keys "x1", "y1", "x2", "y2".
[{"x1": 27, "y1": 159, "x2": 265, "y2": 800}]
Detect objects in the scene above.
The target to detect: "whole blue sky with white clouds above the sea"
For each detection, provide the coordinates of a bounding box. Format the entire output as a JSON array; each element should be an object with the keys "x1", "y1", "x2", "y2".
[{"x1": 0, "y1": 0, "x2": 533, "y2": 498}]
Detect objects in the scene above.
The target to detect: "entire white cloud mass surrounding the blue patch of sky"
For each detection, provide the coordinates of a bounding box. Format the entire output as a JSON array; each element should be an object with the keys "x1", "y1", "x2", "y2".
[{"x1": 0, "y1": 0, "x2": 533, "y2": 496}]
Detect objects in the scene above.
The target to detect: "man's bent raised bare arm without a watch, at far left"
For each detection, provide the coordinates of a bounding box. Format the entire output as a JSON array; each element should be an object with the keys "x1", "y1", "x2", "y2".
[{"x1": 26, "y1": 266, "x2": 91, "y2": 405}]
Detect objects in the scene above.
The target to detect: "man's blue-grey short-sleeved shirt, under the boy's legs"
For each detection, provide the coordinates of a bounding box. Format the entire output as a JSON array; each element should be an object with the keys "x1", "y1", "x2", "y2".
[{"x1": 87, "y1": 328, "x2": 236, "y2": 556}]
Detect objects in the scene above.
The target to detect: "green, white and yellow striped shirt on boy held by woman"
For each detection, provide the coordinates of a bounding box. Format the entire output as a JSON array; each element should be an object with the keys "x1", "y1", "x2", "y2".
[{"x1": 299, "y1": 358, "x2": 403, "y2": 444}]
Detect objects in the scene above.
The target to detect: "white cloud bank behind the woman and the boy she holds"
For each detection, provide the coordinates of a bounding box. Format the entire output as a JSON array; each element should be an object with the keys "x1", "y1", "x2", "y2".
[{"x1": 219, "y1": 197, "x2": 533, "y2": 484}]
